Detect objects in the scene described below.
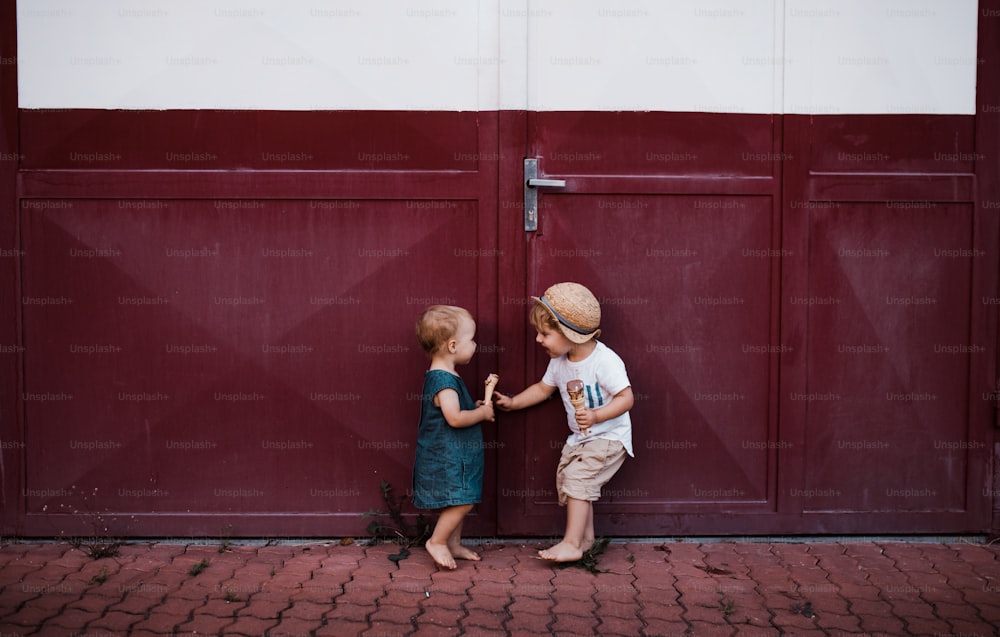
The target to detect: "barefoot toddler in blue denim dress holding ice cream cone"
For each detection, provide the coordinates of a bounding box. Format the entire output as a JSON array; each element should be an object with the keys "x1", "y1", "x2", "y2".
[{"x1": 413, "y1": 305, "x2": 493, "y2": 569}]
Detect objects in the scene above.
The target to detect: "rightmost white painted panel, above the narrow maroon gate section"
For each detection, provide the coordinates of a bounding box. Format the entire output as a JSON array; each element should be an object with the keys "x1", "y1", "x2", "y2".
[{"x1": 784, "y1": 0, "x2": 979, "y2": 114}]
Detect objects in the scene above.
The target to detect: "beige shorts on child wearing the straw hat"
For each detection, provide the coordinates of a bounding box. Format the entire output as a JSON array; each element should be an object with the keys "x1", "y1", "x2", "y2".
[{"x1": 556, "y1": 438, "x2": 625, "y2": 505}]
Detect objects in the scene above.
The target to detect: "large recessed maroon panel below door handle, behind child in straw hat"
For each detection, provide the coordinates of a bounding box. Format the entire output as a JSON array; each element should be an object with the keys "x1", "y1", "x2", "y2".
[{"x1": 531, "y1": 195, "x2": 771, "y2": 502}]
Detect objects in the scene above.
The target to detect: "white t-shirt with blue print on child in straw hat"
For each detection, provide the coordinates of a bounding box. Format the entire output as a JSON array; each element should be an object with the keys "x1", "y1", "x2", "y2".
[{"x1": 542, "y1": 341, "x2": 635, "y2": 457}]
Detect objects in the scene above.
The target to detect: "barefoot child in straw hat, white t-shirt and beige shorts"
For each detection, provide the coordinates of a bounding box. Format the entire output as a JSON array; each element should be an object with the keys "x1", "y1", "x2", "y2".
[{"x1": 494, "y1": 283, "x2": 634, "y2": 562}]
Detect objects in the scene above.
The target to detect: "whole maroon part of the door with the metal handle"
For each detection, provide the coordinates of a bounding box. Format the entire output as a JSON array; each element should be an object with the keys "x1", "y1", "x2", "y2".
[{"x1": 499, "y1": 112, "x2": 784, "y2": 535}]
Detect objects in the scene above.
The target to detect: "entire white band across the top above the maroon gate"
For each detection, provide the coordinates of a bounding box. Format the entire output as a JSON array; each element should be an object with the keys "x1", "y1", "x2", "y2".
[{"x1": 18, "y1": 0, "x2": 979, "y2": 114}]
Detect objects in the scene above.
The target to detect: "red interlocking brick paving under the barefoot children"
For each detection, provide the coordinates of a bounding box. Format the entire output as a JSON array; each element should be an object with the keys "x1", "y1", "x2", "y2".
[{"x1": 0, "y1": 539, "x2": 1000, "y2": 637}]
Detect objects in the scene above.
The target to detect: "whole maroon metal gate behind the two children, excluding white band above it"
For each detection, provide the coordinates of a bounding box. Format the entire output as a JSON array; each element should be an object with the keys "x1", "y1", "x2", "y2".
[{"x1": 0, "y1": 2, "x2": 1000, "y2": 536}]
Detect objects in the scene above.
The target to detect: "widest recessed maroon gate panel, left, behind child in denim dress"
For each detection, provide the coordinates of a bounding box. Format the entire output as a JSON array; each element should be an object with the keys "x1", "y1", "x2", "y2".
[{"x1": 23, "y1": 200, "x2": 490, "y2": 535}]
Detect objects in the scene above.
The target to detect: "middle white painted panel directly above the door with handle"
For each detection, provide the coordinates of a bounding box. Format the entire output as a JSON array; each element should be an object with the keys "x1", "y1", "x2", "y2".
[{"x1": 527, "y1": 0, "x2": 782, "y2": 113}]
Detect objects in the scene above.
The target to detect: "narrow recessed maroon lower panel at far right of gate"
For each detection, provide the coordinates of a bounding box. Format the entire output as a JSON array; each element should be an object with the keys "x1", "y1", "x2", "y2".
[{"x1": 804, "y1": 202, "x2": 976, "y2": 512}]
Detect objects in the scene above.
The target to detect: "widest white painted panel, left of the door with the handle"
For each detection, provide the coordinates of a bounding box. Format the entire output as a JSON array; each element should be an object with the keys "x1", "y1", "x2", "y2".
[{"x1": 18, "y1": 0, "x2": 498, "y2": 110}]
